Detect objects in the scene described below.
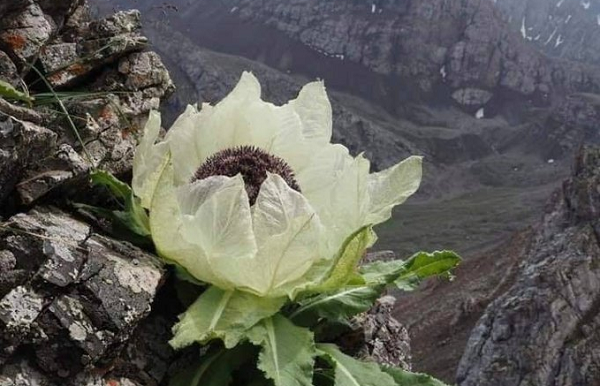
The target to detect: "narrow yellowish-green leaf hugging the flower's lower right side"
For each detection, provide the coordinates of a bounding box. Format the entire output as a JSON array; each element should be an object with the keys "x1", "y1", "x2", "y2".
[{"x1": 311, "y1": 225, "x2": 375, "y2": 292}]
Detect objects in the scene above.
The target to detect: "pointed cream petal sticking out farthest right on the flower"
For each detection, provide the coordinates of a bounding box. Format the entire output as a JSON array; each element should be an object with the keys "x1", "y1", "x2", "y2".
[{"x1": 366, "y1": 156, "x2": 423, "y2": 224}]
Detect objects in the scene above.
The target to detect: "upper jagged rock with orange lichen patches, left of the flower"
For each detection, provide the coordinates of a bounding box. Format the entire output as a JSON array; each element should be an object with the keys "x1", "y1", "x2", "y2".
[{"x1": 0, "y1": 0, "x2": 174, "y2": 208}]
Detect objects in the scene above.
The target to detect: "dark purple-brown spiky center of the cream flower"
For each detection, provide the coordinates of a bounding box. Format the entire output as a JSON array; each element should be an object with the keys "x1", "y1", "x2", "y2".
[{"x1": 193, "y1": 146, "x2": 300, "y2": 205}]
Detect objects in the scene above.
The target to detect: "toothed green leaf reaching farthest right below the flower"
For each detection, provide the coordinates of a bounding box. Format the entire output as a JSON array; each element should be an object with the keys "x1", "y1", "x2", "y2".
[{"x1": 361, "y1": 251, "x2": 461, "y2": 291}]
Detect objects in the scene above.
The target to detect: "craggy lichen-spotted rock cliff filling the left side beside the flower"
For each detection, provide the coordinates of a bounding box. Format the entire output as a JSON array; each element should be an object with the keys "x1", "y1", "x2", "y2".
[{"x1": 0, "y1": 0, "x2": 177, "y2": 386}]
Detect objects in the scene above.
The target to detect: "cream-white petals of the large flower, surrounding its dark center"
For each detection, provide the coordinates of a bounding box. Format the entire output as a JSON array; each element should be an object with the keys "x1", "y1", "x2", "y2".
[{"x1": 133, "y1": 73, "x2": 421, "y2": 297}]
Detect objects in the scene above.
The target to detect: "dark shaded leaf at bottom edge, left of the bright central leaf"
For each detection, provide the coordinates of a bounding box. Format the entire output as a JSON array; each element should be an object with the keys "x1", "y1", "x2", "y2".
[{"x1": 169, "y1": 344, "x2": 256, "y2": 386}]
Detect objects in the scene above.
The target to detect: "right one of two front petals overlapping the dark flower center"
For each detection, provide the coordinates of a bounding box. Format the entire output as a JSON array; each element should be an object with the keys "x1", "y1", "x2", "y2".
[{"x1": 249, "y1": 174, "x2": 324, "y2": 296}]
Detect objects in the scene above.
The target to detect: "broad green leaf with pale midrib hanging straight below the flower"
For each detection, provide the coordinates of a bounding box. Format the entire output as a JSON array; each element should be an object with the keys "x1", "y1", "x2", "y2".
[{"x1": 248, "y1": 314, "x2": 316, "y2": 386}]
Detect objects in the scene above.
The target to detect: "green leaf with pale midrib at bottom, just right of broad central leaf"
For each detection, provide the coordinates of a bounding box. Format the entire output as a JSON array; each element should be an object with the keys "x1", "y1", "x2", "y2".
[{"x1": 317, "y1": 344, "x2": 397, "y2": 386}]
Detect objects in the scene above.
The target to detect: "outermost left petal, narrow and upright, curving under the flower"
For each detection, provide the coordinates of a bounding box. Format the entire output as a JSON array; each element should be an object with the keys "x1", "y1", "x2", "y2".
[{"x1": 150, "y1": 155, "x2": 226, "y2": 289}]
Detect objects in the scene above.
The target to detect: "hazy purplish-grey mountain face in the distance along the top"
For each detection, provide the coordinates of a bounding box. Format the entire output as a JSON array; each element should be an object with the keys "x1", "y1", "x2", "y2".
[{"x1": 97, "y1": 0, "x2": 600, "y2": 108}]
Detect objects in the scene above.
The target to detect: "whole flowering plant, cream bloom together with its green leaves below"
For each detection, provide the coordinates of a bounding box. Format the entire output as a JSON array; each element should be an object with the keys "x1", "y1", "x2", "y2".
[{"x1": 117, "y1": 72, "x2": 460, "y2": 386}]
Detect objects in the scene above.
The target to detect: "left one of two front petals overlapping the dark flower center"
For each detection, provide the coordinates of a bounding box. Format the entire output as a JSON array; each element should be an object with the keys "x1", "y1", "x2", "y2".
[{"x1": 179, "y1": 175, "x2": 257, "y2": 288}]
